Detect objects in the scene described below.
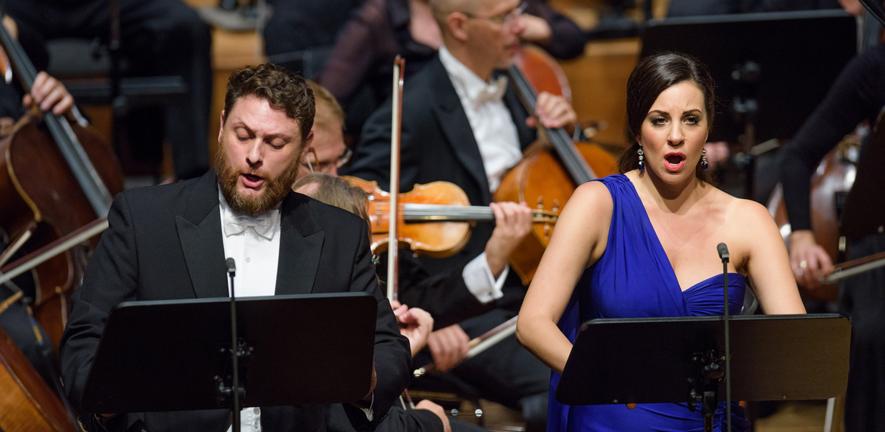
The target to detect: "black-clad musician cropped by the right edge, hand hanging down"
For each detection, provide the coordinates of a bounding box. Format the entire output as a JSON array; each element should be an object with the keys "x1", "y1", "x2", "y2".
[{"x1": 780, "y1": 38, "x2": 885, "y2": 432}]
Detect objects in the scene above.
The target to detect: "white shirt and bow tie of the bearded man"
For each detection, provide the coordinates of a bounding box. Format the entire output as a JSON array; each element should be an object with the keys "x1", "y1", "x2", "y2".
[{"x1": 218, "y1": 191, "x2": 280, "y2": 432}]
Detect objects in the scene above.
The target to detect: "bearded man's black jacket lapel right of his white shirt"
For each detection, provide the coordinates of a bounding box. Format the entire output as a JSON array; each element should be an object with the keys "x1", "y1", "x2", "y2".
[{"x1": 275, "y1": 193, "x2": 325, "y2": 294}]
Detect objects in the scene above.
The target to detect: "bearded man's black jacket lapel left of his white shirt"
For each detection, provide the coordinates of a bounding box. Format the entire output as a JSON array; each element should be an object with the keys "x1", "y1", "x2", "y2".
[{"x1": 175, "y1": 172, "x2": 229, "y2": 297}]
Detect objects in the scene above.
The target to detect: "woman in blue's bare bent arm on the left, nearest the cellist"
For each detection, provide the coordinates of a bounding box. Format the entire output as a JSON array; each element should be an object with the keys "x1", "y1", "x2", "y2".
[{"x1": 516, "y1": 182, "x2": 613, "y2": 372}]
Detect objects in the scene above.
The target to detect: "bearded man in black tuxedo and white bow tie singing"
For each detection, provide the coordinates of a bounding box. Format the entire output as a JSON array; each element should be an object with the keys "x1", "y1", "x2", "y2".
[{"x1": 61, "y1": 64, "x2": 409, "y2": 432}]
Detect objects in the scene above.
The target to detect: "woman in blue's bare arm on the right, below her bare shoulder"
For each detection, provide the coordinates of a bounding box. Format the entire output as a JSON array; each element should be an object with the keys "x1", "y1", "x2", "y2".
[{"x1": 730, "y1": 200, "x2": 805, "y2": 315}]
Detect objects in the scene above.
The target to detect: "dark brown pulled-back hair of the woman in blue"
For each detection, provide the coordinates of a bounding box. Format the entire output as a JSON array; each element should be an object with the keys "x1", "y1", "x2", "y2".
[{"x1": 619, "y1": 53, "x2": 716, "y2": 178}]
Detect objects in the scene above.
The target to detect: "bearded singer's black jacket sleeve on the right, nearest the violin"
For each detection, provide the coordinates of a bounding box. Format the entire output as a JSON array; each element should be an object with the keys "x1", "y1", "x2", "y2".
[{"x1": 350, "y1": 223, "x2": 411, "y2": 419}]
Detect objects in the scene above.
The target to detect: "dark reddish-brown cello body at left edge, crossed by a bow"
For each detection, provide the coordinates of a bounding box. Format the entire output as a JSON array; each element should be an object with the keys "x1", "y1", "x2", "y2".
[{"x1": 0, "y1": 113, "x2": 123, "y2": 348}]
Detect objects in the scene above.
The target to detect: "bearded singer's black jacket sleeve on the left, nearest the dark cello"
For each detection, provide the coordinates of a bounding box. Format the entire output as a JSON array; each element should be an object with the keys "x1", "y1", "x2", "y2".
[{"x1": 61, "y1": 194, "x2": 138, "y2": 408}]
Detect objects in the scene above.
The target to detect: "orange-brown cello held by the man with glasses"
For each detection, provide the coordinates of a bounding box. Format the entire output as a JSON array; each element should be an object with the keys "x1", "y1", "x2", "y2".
[{"x1": 494, "y1": 46, "x2": 618, "y2": 285}]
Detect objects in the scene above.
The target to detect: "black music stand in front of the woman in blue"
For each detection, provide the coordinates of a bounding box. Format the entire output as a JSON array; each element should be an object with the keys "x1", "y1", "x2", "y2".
[{"x1": 556, "y1": 314, "x2": 851, "y2": 430}]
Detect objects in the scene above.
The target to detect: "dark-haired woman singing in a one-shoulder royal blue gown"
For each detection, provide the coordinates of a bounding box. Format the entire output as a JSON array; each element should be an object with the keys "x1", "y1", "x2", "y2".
[{"x1": 517, "y1": 53, "x2": 805, "y2": 432}]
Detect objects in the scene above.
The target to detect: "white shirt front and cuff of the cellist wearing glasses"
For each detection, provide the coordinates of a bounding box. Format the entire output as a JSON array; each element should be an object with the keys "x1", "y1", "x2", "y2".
[{"x1": 439, "y1": 46, "x2": 522, "y2": 303}]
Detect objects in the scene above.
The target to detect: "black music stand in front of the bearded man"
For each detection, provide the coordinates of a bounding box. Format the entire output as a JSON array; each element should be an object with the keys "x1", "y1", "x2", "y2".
[{"x1": 81, "y1": 293, "x2": 377, "y2": 413}]
